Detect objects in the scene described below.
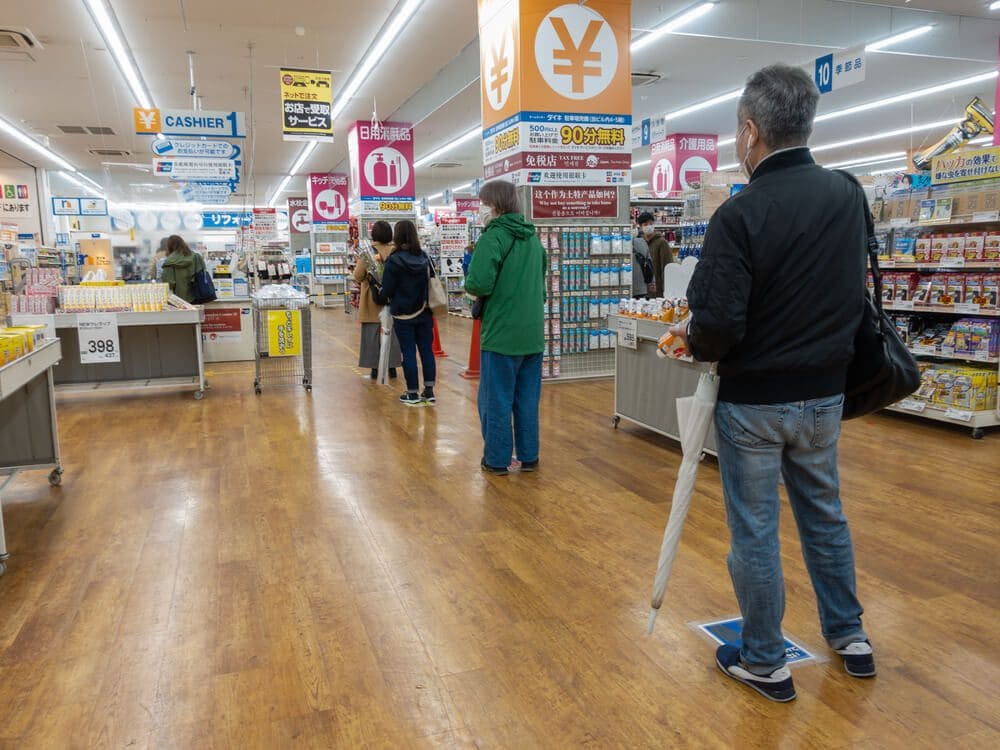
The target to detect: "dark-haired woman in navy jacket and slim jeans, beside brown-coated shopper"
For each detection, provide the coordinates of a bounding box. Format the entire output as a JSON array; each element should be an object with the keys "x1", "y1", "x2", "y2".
[{"x1": 369, "y1": 220, "x2": 437, "y2": 406}]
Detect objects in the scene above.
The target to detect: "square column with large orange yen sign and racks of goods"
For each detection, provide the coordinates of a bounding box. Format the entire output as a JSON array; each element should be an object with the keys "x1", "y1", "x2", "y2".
[{"x1": 479, "y1": 0, "x2": 632, "y2": 378}]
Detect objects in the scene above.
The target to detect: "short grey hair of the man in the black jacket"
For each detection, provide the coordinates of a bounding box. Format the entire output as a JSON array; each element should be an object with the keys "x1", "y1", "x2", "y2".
[{"x1": 737, "y1": 63, "x2": 819, "y2": 149}]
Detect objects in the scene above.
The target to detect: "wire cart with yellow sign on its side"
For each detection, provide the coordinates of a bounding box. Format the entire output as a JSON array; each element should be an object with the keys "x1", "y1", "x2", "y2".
[{"x1": 253, "y1": 294, "x2": 312, "y2": 396}]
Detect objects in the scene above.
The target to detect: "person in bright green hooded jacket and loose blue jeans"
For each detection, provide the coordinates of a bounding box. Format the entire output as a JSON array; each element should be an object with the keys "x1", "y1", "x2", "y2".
[{"x1": 465, "y1": 180, "x2": 546, "y2": 475}]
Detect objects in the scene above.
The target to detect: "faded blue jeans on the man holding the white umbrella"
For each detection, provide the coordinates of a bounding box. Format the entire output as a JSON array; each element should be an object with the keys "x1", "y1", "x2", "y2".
[{"x1": 715, "y1": 396, "x2": 867, "y2": 674}]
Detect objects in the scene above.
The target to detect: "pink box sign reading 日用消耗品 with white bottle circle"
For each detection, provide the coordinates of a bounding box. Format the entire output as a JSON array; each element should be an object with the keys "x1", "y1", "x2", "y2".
[{"x1": 347, "y1": 121, "x2": 416, "y2": 201}]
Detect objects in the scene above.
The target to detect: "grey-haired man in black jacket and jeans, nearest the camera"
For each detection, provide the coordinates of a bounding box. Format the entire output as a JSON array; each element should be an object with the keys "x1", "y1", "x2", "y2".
[{"x1": 672, "y1": 65, "x2": 875, "y2": 701}]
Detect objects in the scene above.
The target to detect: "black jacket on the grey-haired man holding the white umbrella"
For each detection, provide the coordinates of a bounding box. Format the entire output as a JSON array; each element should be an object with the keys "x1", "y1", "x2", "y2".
[{"x1": 688, "y1": 148, "x2": 867, "y2": 404}]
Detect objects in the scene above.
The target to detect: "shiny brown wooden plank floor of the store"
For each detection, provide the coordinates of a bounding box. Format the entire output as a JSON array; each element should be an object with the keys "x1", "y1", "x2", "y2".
[{"x1": 0, "y1": 310, "x2": 1000, "y2": 750}]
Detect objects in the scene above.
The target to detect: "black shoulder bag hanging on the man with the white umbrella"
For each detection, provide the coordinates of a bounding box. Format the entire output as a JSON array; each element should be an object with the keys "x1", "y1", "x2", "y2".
[{"x1": 842, "y1": 173, "x2": 920, "y2": 419}]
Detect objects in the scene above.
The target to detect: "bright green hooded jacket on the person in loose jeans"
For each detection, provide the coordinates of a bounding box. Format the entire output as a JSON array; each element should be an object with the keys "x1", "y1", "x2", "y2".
[{"x1": 465, "y1": 214, "x2": 546, "y2": 357}]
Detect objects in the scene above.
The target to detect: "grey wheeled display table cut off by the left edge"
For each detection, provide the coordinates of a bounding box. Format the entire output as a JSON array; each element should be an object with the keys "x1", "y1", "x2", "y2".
[{"x1": 0, "y1": 339, "x2": 63, "y2": 575}]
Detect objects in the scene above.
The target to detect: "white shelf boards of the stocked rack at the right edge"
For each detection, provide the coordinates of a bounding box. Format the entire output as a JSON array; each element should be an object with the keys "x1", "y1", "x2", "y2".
[{"x1": 879, "y1": 220, "x2": 1000, "y2": 438}]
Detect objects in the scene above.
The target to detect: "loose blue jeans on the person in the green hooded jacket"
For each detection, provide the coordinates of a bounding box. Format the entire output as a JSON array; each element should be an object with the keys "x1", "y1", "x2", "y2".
[{"x1": 479, "y1": 352, "x2": 542, "y2": 469}]
